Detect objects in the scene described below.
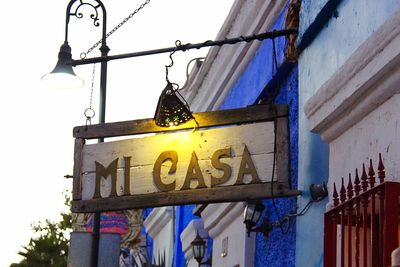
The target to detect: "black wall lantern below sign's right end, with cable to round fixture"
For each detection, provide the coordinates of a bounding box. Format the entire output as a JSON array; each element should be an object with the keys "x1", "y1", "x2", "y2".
[{"x1": 243, "y1": 184, "x2": 328, "y2": 237}]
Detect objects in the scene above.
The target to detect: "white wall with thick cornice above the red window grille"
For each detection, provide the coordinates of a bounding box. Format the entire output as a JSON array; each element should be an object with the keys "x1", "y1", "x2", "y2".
[{"x1": 305, "y1": 10, "x2": 400, "y2": 197}]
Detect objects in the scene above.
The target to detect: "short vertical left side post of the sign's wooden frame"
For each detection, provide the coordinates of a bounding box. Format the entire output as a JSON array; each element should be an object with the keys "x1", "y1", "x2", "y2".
[{"x1": 72, "y1": 138, "x2": 85, "y2": 200}]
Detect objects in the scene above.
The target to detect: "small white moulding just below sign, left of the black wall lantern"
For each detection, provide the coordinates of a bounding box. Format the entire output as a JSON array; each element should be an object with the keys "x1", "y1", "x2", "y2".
[{"x1": 201, "y1": 202, "x2": 245, "y2": 238}]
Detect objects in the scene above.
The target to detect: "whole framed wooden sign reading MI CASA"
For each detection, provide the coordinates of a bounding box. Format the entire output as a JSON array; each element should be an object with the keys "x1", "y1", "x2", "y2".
[{"x1": 72, "y1": 105, "x2": 299, "y2": 213}]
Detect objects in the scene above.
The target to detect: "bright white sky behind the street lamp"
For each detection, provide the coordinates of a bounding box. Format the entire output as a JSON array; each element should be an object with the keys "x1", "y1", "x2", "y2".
[{"x1": 0, "y1": 0, "x2": 234, "y2": 266}]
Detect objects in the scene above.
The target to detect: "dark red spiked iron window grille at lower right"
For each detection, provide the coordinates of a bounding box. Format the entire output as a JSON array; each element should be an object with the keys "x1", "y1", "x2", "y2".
[{"x1": 324, "y1": 155, "x2": 400, "y2": 267}]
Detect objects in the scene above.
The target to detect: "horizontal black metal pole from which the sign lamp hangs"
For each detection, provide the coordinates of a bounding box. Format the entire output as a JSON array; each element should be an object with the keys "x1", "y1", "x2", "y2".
[{"x1": 70, "y1": 29, "x2": 298, "y2": 66}]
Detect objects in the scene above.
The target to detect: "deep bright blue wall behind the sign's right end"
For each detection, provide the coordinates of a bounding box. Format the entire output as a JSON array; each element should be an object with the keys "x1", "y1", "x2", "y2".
[{"x1": 220, "y1": 4, "x2": 298, "y2": 267}]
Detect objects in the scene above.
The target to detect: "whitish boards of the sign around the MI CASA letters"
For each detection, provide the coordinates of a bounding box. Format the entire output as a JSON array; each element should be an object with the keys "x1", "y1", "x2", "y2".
[{"x1": 82, "y1": 122, "x2": 276, "y2": 199}]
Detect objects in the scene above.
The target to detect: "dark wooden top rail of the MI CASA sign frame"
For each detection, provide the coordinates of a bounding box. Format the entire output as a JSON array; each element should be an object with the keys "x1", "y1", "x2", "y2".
[{"x1": 73, "y1": 105, "x2": 288, "y2": 139}]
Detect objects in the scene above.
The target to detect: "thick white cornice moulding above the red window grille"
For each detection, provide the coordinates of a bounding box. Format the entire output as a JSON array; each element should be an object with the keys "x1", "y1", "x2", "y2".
[{"x1": 304, "y1": 11, "x2": 400, "y2": 143}]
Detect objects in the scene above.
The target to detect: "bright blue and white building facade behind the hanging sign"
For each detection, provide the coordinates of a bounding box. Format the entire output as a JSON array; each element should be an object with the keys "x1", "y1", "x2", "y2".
[{"x1": 144, "y1": 0, "x2": 298, "y2": 266}]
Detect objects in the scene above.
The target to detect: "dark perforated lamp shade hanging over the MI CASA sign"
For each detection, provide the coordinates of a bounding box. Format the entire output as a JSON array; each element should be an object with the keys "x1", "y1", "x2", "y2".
[{"x1": 154, "y1": 82, "x2": 193, "y2": 127}]
